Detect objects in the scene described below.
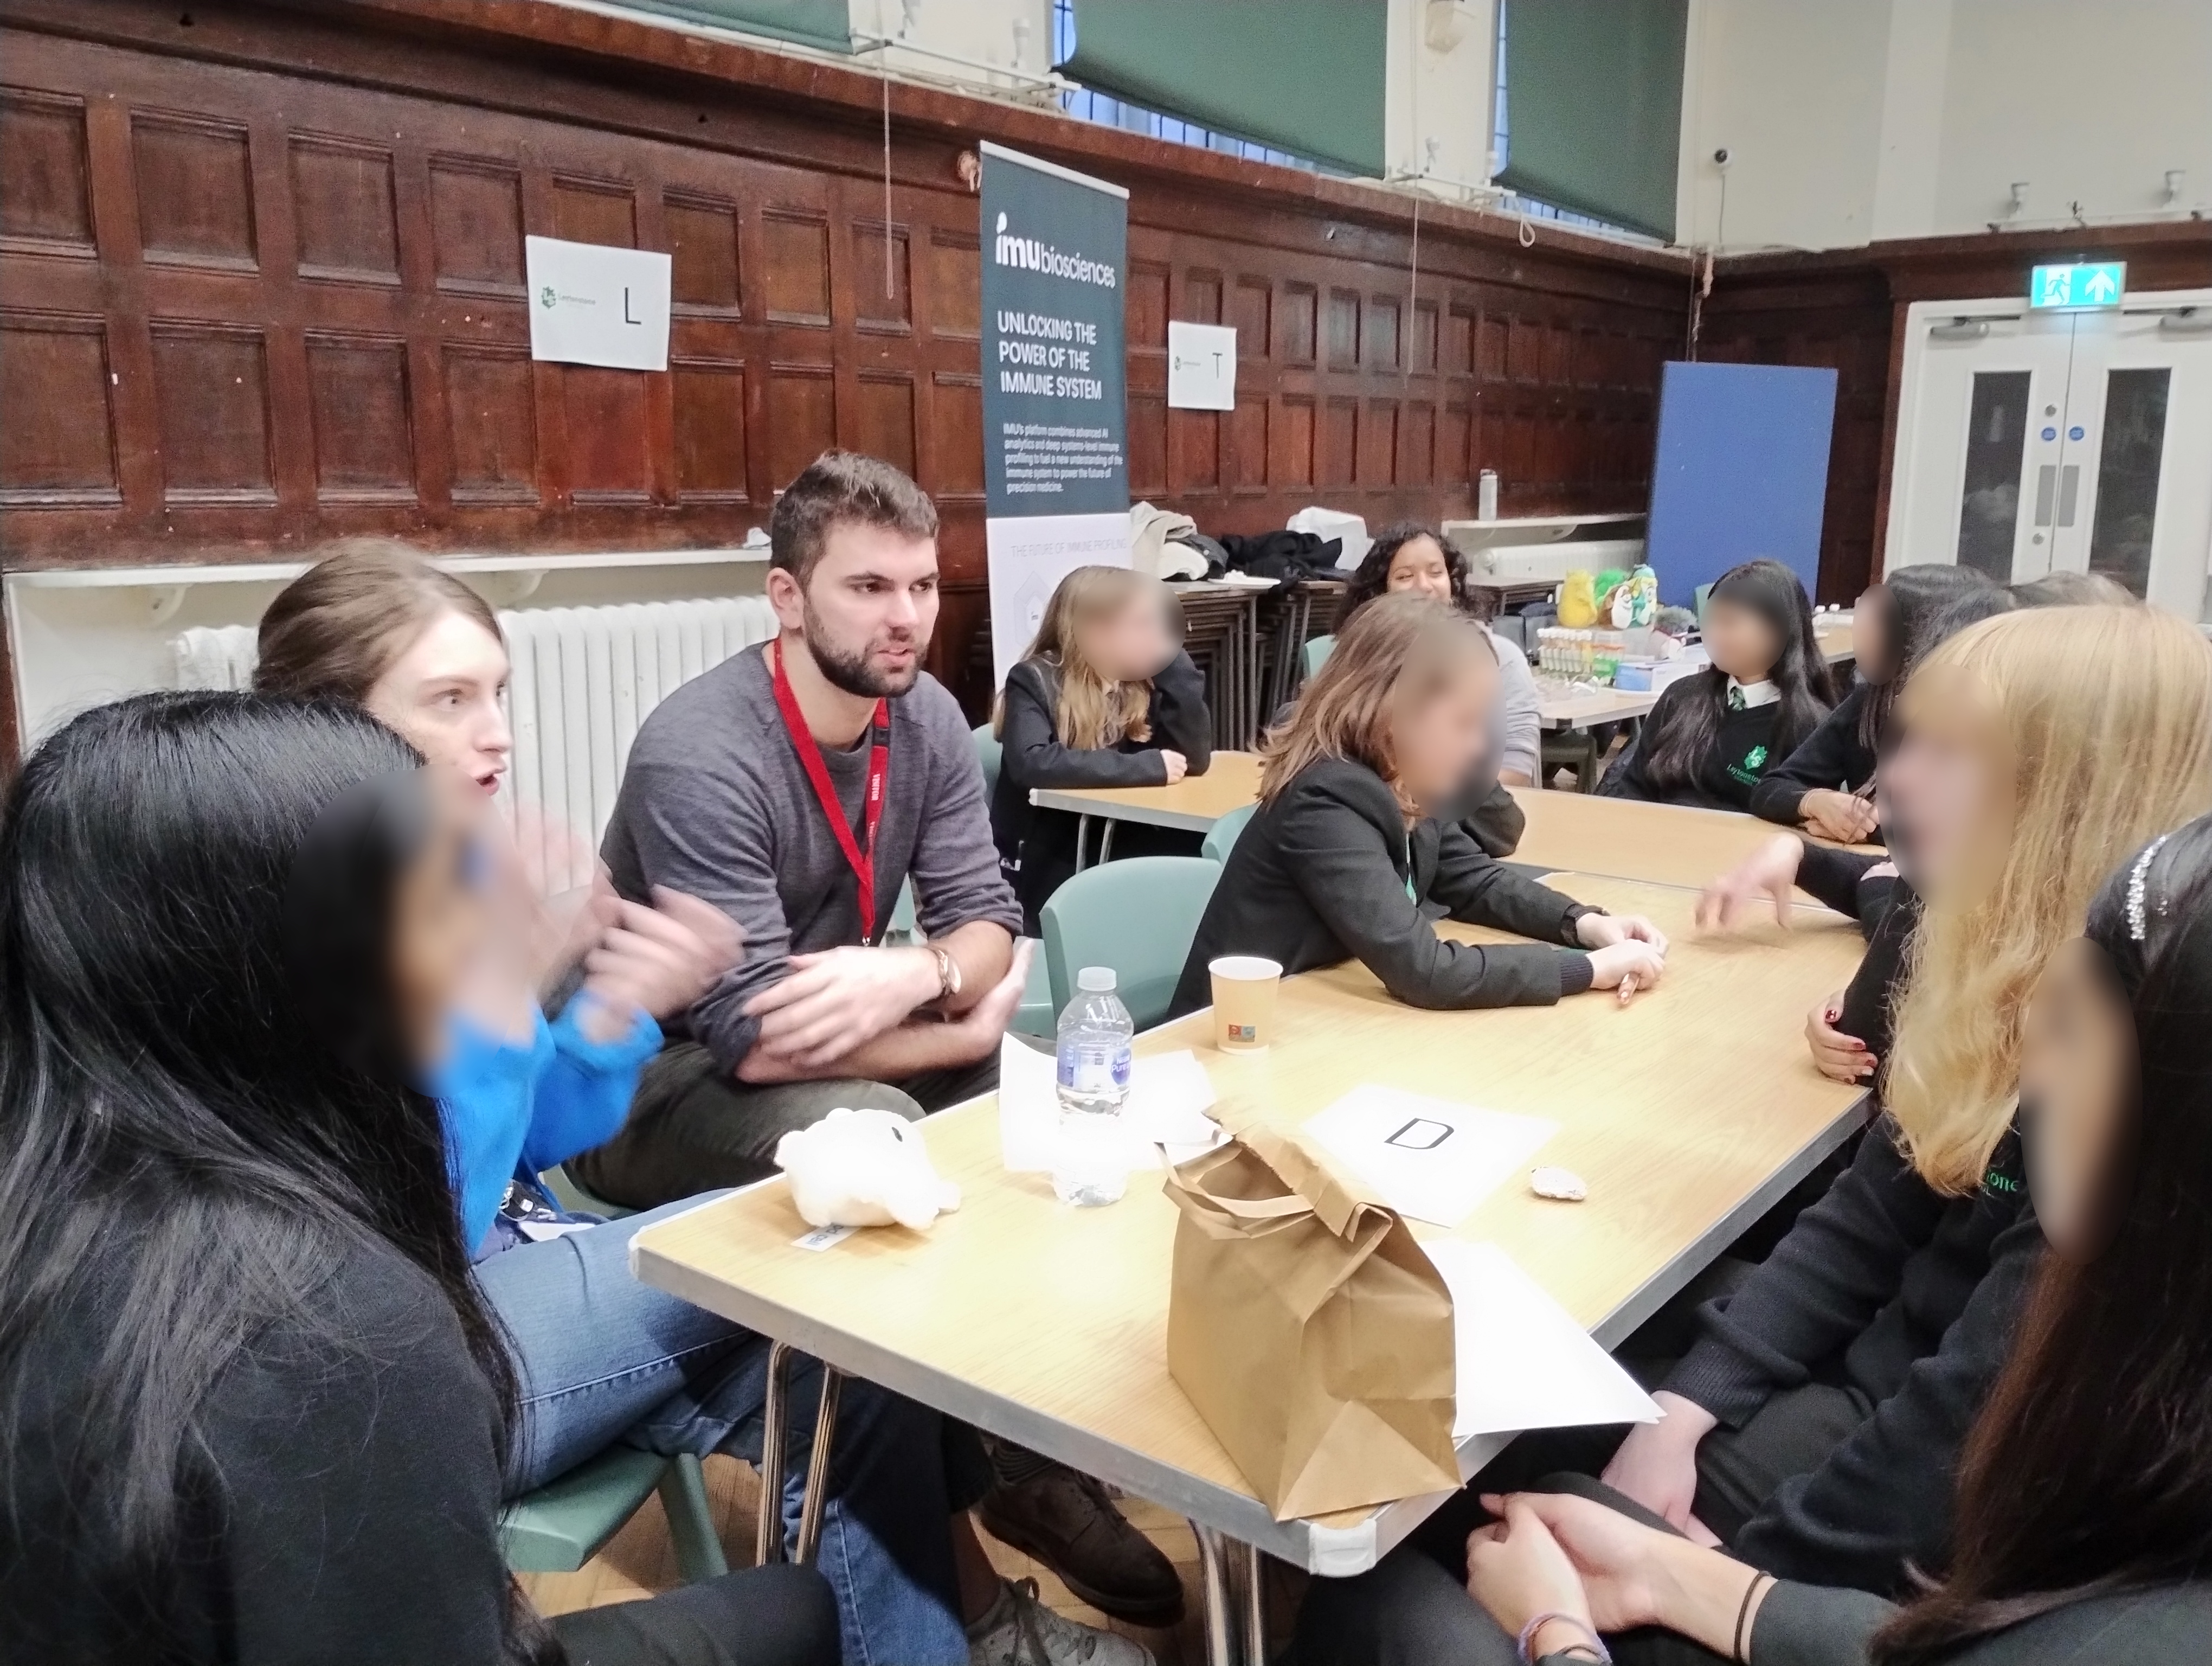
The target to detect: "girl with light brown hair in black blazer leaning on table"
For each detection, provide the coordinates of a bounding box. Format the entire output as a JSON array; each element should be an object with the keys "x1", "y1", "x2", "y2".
[{"x1": 1174, "y1": 595, "x2": 1666, "y2": 1013}]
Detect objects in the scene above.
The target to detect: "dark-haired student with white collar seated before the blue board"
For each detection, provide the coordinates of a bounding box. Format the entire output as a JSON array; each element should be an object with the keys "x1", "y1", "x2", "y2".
[{"x1": 1597, "y1": 560, "x2": 1834, "y2": 810}]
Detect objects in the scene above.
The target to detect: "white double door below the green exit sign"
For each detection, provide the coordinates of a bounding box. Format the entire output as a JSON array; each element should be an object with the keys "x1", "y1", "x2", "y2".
[{"x1": 1885, "y1": 292, "x2": 2212, "y2": 619}]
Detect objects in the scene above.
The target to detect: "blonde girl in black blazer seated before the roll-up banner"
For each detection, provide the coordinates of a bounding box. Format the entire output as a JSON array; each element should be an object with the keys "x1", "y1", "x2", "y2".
[{"x1": 991, "y1": 566, "x2": 1214, "y2": 936}]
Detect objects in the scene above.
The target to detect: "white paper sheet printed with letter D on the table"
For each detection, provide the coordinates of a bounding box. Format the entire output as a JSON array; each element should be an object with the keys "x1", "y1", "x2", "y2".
[{"x1": 1305, "y1": 1082, "x2": 1559, "y2": 1226}]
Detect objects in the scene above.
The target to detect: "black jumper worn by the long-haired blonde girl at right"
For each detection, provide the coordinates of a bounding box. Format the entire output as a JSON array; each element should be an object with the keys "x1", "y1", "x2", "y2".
[{"x1": 1663, "y1": 1119, "x2": 2044, "y2": 1595}]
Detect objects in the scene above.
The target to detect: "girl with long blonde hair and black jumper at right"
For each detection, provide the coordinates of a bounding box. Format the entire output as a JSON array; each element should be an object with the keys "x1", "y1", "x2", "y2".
[{"x1": 1606, "y1": 606, "x2": 2212, "y2": 1595}]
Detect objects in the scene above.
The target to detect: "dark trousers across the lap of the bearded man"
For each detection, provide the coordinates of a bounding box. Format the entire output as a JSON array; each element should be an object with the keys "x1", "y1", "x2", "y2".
[{"x1": 566, "y1": 1042, "x2": 998, "y2": 1208}]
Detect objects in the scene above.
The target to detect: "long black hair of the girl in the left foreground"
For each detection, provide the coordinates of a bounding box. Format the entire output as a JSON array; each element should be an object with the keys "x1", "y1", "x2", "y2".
[{"x1": 0, "y1": 693, "x2": 529, "y2": 1659}]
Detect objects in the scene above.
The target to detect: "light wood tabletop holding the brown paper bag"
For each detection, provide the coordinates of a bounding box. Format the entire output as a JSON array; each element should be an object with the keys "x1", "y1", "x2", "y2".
[{"x1": 633, "y1": 874, "x2": 1862, "y2": 1573}]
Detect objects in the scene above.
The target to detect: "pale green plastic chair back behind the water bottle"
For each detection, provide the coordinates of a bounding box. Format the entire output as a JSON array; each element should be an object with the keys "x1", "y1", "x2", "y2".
[{"x1": 1044, "y1": 856, "x2": 1221, "y2": 1029}]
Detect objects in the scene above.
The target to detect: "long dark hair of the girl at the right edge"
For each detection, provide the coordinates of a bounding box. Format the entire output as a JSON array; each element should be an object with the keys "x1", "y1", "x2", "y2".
[{"x1": 1874, "y1": 816, "x2": 2212, "y2": 1666}]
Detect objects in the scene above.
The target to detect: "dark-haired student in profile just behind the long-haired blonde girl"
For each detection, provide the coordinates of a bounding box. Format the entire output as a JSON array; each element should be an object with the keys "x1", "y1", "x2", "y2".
[{"x1": 1752, "y1": 562, "x2": 1999, "y2": 845}]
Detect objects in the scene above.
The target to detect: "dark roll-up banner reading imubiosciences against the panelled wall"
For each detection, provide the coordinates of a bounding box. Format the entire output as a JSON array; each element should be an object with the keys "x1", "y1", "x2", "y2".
[{"x1": 980, "y1": 142, "x2": 1128, "y2": 684}]
